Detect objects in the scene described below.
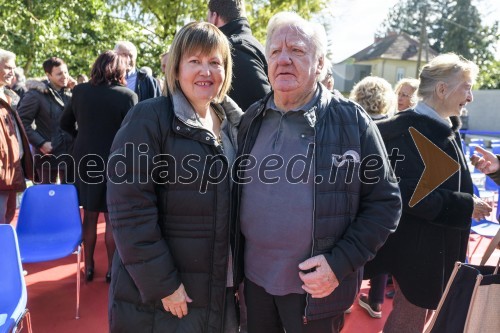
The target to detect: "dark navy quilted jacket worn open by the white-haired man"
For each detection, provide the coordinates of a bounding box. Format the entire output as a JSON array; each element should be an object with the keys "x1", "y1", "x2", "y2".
[{"x1": 233, "y1": 89, "x2": 401, "y2": 320}]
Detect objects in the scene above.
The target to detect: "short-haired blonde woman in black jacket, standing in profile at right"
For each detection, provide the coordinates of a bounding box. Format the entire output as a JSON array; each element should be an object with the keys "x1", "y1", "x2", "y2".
[{"x1": 366, "y1": 54, "x2": 491, "y2": 333}]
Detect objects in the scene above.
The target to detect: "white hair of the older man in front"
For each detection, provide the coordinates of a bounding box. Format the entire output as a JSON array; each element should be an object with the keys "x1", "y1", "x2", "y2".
[{"x1": 266, "y1": 12, "x2": 327, "y2": 58}]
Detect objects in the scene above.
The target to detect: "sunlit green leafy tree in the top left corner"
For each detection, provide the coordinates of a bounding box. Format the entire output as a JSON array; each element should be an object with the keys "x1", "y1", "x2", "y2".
[{"x1": 0, "y1": 0, "x2": 146, "y2": 77}]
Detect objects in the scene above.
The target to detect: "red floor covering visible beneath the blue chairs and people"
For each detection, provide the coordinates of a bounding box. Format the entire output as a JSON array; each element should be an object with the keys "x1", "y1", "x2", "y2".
[{"x1": 14, "y1": 217, "x2": 500, "y2": 333}]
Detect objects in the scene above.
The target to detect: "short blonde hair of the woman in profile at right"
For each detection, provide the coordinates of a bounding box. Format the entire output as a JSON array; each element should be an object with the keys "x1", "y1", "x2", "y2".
[{"x1": 418, "y1": 53, "x2": 479, "y2": 99}]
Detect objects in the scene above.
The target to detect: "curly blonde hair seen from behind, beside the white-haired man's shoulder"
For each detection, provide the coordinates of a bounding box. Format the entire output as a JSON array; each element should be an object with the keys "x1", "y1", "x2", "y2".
[{"x1": 349, "y1": 76, "x2": 396, "y2": 115}]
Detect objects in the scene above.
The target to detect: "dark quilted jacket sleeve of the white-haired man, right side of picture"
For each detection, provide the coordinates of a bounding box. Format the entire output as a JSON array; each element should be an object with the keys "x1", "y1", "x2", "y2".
[{"x1": 326, "y1": 122, "x2": 401, "y2": 282}]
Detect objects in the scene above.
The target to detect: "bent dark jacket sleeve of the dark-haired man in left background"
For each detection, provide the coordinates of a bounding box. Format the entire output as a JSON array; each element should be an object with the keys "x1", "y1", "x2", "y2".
[{"x1": 17, "y1": 90, "x2": 47, "y2": 148}]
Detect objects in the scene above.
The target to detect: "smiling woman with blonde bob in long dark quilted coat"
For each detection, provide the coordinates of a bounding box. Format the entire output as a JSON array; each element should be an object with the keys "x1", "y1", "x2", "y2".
[{"x1": 108, "y1": 23, "x2": 242, "y2": 333}]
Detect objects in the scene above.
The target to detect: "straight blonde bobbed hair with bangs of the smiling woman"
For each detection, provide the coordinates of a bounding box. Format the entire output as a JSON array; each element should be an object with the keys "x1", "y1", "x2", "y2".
[{"x1": 165, "y1": 22, "x2": 233, "y2": 102}]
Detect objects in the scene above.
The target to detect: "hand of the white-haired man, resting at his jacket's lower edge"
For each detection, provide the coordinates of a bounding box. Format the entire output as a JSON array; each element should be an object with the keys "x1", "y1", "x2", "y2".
[{"x1": 299, "y1": 255, "x2": 339, "y2": 298}]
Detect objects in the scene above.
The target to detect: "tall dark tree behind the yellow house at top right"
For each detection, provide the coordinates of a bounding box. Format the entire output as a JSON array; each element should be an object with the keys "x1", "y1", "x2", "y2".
[{"x1": 382, "y1": 0, "x2": 500, "y2": 89}]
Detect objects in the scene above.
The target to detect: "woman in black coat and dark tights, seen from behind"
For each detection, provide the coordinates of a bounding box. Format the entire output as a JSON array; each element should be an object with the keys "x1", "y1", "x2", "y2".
[{"x1": 61, "y1": 51, "x2": 137, "y2": 282}]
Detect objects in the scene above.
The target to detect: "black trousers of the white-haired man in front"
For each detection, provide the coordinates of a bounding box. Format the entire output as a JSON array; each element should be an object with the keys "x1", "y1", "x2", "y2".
[{"x1": 245, "y1": 279, "x2": 344, "y2": 333}]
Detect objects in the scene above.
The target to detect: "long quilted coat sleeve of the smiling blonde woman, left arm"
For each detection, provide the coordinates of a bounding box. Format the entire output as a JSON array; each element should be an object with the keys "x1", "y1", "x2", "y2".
[{"x1": 107, "y1": 100, "x2": 181, "y2": 302}]
